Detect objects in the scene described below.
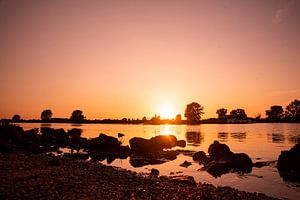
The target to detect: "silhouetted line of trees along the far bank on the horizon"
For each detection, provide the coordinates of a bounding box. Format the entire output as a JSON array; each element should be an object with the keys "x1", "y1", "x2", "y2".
[{"x1": 6, "y1": 99, "x2": 300, "y2": 124}]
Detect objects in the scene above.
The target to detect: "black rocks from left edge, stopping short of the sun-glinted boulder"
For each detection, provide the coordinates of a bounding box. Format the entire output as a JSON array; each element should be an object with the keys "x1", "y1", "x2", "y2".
[{"x1": 0, "y1": 125, "x2": 130, "y2": 162}]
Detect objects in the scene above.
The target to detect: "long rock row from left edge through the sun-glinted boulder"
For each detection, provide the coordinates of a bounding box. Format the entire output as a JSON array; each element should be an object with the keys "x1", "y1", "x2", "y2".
[{"x1": 0, "y1": 125, "x2": 186, "y2": 167}]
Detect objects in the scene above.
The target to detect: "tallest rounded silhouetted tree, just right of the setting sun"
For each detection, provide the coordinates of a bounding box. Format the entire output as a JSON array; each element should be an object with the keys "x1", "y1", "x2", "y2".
[{"x1": 184, "y1": 102, "x2": 204, "y2": 124}]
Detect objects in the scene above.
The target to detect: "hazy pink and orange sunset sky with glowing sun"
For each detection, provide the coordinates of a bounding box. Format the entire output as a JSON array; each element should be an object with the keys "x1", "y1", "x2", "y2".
[{"x1": 0, "y1": 0, "x2": 300, "y2": 119}]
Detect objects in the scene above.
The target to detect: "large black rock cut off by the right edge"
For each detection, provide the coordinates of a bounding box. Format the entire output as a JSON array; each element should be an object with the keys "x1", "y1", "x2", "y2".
[{"x1": 277, "y1": 143, "x2": 300, "y2": 182}]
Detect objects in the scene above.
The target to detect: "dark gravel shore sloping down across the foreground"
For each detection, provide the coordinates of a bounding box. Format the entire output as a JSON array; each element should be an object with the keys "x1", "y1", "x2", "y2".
[{"x1": 0, "y1": 152, "x2": 274, "y2": 200}]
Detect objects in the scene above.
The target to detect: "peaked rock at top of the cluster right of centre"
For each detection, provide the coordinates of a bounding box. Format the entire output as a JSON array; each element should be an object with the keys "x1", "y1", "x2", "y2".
[{"x1": 208, "y1": 141, "x2": 233, "y2": 159}]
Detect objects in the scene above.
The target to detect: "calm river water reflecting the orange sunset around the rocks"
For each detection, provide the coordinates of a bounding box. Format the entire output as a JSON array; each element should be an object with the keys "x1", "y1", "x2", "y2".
[{"x1": 20, "y1": 123, "x2": 300, "y2": 199}]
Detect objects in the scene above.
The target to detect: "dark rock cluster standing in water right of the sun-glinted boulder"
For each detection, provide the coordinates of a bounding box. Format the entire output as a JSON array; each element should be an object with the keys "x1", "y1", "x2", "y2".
[{"x1": 193, "y1": 141, "x2": 252, "y2": 177}]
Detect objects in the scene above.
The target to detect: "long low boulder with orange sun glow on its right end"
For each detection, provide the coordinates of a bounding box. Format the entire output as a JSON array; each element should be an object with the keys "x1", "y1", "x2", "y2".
[{"x1": 129, "y1": 135, "x2": 177, "y2": 153}]
